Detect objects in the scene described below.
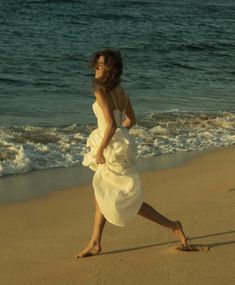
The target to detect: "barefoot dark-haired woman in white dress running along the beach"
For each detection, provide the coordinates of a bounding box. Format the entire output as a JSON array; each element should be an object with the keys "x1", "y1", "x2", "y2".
[{"x1": 76, "y1": 49, "x2": 187, "y2": 258}]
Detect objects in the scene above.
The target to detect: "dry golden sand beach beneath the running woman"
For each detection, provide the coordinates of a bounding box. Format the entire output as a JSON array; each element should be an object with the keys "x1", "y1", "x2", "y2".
[{"x1": 0, "y1": 146, "x2": 235, "y2": 285}]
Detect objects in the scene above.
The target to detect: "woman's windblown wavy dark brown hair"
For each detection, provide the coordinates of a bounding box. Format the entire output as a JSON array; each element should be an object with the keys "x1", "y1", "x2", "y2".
[{"x1": 89, "y1": 49, "x2": 123, "y2": 93}]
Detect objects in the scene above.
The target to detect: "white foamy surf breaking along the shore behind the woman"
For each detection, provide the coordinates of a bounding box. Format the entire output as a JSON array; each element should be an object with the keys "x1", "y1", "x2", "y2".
[{"x1": 0, "y1": 110, "x2": 235, "y2": 176}]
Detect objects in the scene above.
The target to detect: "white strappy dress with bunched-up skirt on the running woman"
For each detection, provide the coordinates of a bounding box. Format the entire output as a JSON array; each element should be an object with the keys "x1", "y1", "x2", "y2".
[{"x1": 82, "y1": 93, "x2": 144, "y2": 227}]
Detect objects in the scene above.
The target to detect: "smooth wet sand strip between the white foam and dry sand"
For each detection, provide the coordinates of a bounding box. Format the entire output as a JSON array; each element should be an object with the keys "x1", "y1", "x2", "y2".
[{"x1": 0, "y1": 146, "x2": 220, "y2": 205}]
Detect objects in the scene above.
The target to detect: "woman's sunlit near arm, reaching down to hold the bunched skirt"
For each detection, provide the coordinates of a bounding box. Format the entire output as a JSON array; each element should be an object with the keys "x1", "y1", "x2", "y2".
[{"x1": 95, "y1": 91, "x2": 117, "y2": 163}]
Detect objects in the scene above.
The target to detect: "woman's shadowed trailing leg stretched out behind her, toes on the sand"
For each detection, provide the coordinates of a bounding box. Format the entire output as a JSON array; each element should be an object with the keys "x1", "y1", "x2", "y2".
[{"x1": 138, "y1": 202, "x2": 187, "y2": 245}]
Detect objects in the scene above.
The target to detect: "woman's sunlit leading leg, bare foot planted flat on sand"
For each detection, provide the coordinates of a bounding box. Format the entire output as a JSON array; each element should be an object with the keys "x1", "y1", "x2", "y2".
[{"x1": 75, "y1": 197, "x2": 106, "y2": 258}]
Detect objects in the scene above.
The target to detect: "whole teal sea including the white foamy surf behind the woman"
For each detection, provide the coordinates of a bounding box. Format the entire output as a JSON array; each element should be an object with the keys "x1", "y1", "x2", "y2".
[{"x1": 0, "y1": 0, "x2": 235, "y2": 176}]
